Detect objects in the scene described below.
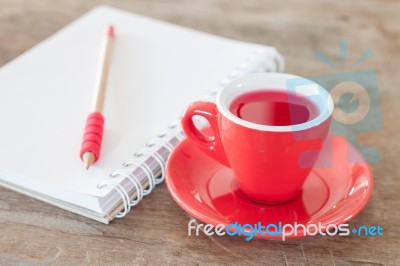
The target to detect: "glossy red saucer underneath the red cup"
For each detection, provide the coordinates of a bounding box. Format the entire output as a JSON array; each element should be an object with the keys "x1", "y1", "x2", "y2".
[{"x1": 166, "y1": 133, "x2": 373, "y2": 238}]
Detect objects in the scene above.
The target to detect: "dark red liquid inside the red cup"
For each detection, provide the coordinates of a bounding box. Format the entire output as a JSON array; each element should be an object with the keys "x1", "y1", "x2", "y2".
[{"x1": 229, "y1": 90, "x2": 317, "y2": 126}]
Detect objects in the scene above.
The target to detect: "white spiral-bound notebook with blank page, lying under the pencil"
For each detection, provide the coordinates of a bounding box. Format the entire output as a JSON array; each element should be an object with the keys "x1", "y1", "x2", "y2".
[{"x1": 0, "y1": 6, "x2": 283, "y2": 223}]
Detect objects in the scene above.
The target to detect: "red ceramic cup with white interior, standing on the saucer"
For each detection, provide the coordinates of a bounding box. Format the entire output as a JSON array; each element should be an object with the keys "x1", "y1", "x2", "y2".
[{"x1": 182, "y1": 73, "x2": 333, "y2": 204}]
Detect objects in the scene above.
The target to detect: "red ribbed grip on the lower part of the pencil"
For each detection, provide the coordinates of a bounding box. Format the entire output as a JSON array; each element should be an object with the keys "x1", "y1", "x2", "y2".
[{"x1": 80, "y1": 112, "x2": 104, "y2": 162}]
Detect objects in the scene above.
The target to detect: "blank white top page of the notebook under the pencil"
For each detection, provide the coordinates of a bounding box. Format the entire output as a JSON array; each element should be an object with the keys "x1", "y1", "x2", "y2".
[{"x1": 0, "y1": 7, "x2": 273, "y2": 202}]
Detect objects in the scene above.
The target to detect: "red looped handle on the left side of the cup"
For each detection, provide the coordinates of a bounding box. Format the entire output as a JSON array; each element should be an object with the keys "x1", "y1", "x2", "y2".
[{"x1": 181, "y1": 102, "x2": 230, "y2": 167}]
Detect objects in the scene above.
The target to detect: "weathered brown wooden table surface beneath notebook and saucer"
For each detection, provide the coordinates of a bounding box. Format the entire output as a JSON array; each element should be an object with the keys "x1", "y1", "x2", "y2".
[{"x1": 0, "y1": 0, "x2": 400, "y2": 265}]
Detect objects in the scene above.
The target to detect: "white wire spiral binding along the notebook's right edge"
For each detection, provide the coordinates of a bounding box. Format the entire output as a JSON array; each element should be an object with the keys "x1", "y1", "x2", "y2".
[{"x1": 97, "y1": 47, "x2": 285, "y2": 218}]
